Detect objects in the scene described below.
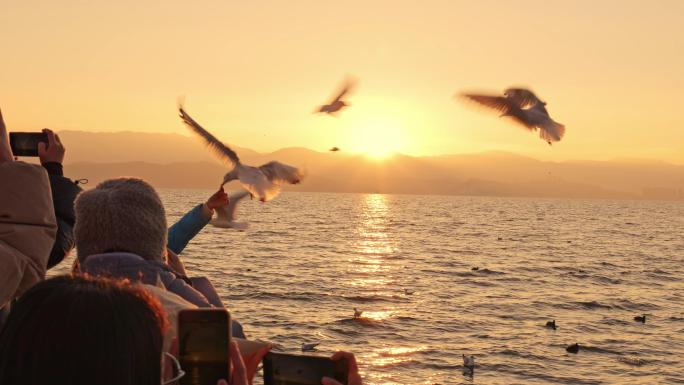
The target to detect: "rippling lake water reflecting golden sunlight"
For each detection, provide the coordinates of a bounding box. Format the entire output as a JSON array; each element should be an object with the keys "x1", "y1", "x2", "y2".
[{"x1": 53, "y1": 190, "x2": 684, "y2": 384}]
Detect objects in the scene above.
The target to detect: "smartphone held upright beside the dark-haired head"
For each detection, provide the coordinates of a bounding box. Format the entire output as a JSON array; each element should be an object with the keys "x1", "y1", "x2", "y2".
[{"x1": 178, "y1": 308, "x2": 230, "y2": 385}]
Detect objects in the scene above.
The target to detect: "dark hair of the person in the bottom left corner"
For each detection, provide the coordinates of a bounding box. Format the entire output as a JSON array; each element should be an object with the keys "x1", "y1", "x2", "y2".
[{"x1": 0, "y1": 275, "x2": 167, "y2": 385}]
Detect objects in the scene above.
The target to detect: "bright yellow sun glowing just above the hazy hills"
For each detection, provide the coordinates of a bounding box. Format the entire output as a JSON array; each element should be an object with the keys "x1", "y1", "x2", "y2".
[{"x1": 349, "y1": 117, "x2": 405, "y2": 160}]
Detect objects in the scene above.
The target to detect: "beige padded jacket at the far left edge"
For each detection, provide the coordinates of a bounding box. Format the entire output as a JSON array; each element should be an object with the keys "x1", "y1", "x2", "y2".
[{"x1": 0, "y1": 162, "x2": 57, "y2": 307}]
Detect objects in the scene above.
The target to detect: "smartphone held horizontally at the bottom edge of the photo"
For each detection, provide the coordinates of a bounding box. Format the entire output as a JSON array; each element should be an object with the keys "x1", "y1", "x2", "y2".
[{"x1": 264, "y1": 352, "x2": 348, "y2": 385}]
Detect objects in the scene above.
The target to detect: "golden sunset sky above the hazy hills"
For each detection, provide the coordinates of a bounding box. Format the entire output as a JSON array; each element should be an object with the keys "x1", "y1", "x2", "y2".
[{"x1": 0, "y1": 0, "x2": 684, "y2": 164}]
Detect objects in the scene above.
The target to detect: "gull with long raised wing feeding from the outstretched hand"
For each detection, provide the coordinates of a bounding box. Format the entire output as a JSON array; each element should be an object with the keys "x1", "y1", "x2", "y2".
[{"x1": 178, "y1": 105, "x2": 304, "y2": 202}]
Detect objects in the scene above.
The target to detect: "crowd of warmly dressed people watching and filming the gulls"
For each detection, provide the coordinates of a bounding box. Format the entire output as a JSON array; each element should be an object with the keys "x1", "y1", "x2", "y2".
[{"x1": 0, "y1": 109, "x2": 361, "y2": 385}]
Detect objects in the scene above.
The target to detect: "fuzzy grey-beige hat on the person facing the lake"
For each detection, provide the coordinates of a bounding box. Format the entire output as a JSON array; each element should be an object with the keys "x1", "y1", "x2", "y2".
[{"x1": 74, "y1": 178, "x2": 167, "y2": 262}]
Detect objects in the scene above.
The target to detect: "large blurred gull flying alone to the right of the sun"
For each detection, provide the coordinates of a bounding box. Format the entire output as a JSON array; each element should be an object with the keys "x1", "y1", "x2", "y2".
[{"x1": 462, "y1": 88, "x2": 565, "y2": 145}]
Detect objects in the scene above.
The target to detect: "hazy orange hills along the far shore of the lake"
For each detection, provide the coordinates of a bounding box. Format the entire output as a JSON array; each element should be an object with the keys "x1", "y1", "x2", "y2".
[{"x1": 59, "y1": 131, "x2": 684, "y2": 199}]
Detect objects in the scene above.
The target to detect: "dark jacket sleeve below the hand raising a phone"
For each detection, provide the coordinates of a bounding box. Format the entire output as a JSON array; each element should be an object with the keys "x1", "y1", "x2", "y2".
[{"x1": 43, "y1": 162, "x2": 83, "y2": 269}]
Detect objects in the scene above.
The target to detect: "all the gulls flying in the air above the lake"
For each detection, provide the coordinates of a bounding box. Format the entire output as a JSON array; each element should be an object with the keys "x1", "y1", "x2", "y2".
[{"x1": 178, "y1": 80, "x2": 565, "y2": 230}]
